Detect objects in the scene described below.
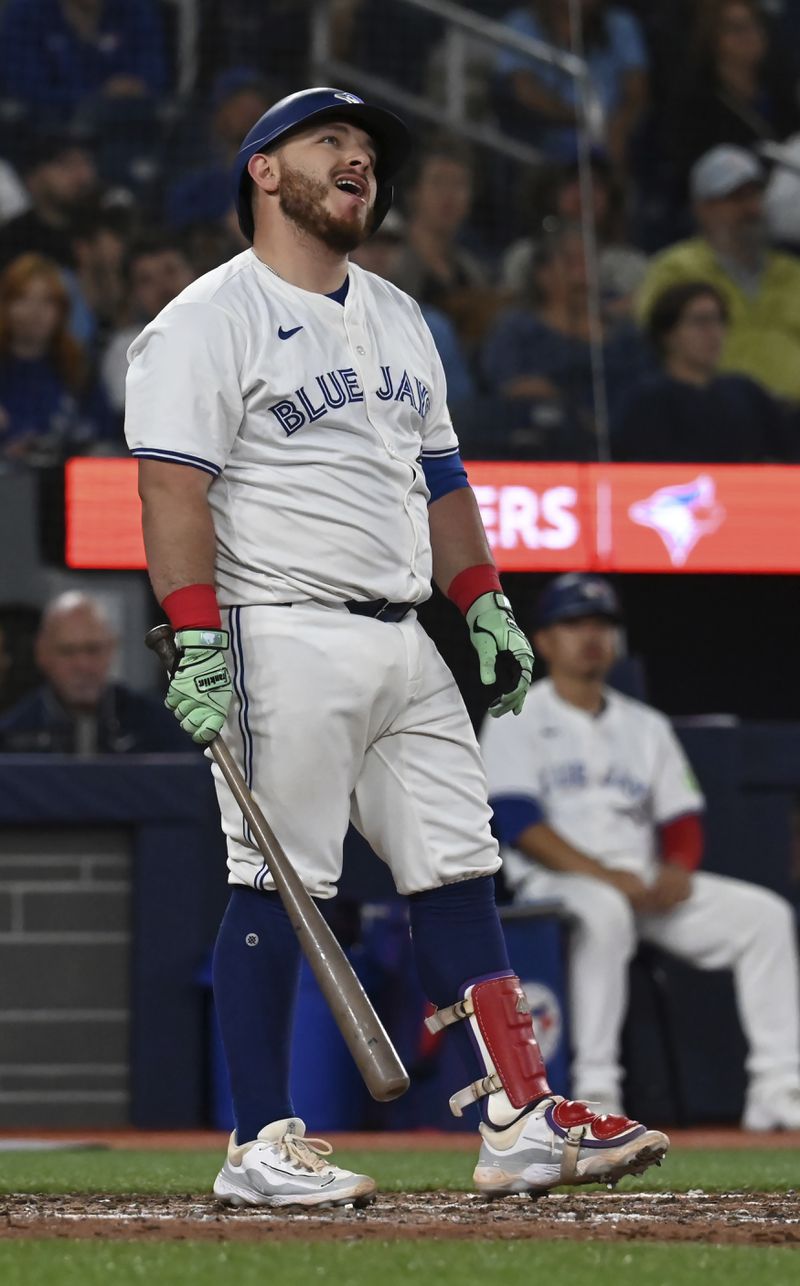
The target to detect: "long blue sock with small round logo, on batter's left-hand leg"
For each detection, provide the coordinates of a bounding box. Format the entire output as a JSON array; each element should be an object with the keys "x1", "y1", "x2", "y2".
[{"x1": 212, "y1": 886, "x2": 300, "y2": 1143}]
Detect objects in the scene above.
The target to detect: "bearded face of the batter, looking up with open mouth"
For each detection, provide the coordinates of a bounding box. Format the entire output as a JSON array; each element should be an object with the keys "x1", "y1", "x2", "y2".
[{"x1": 278, "y1": 121, "x2": 377, "y2": 255}]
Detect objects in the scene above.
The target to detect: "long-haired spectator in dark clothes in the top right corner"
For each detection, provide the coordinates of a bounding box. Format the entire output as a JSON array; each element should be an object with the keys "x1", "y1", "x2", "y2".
[{"x1": 665, "y1": 0, "x2": 800, "y2": 181}]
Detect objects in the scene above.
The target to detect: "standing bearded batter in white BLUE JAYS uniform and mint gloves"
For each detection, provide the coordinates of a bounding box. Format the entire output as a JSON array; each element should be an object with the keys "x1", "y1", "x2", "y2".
[{"x1": 126, "y1": 89, "x2": 668, "y2": 1206}]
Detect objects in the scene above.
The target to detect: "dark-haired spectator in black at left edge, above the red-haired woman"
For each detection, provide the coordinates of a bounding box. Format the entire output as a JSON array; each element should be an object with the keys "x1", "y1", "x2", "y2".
[{"x1": 0, "y1": 132, "x2": 96, "y2": 269}]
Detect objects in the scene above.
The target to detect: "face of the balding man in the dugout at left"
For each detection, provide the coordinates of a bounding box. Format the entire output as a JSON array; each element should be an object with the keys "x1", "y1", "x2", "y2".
[{"x1": 36, "y1": 608, "x2": 114, "y2": 710}]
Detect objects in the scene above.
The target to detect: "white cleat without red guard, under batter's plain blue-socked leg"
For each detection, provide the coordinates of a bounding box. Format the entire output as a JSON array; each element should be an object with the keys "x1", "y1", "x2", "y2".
[{"x1": 214, "y1": 1116, "x2": 376, "y2": 1208}]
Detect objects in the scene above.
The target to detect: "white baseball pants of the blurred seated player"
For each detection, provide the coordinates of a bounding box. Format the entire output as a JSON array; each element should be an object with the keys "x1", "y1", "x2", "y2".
[{"x1": 517, "y1": 867, "x2": 800, "y2": 1097}]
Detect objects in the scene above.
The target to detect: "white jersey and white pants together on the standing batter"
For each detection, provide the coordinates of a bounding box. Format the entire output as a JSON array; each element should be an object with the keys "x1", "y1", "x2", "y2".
[{"x1": 126, "y1": 251, "x2": 500, "y2": 898}]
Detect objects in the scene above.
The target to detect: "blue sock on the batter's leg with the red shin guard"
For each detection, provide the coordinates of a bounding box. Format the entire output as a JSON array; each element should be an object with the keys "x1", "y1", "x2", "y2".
[{"x1": 409, "y1": 876, "x2": 511, "y2": 1111}]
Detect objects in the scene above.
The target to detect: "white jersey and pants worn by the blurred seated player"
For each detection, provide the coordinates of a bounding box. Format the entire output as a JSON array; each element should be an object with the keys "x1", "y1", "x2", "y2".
[{"x1": 482, "y1": 679, "x2": 800, "y2": 1106}]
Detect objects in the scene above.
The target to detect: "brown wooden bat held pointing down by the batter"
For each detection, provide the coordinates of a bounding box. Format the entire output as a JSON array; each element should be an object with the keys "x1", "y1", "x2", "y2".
[{"x1": 144, "y1": 625, "x2": 410, "y2": 1103}]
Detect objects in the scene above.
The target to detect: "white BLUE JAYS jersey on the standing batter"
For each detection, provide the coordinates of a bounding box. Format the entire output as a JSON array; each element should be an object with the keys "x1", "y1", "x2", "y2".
[{"x1": 125, "y1": 249, "x2": 458, "y2": 607}]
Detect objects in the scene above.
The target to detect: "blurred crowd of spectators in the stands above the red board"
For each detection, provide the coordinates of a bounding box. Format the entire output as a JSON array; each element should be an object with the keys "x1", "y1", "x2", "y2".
[{"x1": 0, "y1": 0, "x2": 800, "y2": 469}]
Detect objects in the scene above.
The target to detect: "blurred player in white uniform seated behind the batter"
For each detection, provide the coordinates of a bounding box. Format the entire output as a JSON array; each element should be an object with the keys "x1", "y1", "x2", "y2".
[{"x1": 482, "y1": 575, "x2": 800, "y2": 1130}]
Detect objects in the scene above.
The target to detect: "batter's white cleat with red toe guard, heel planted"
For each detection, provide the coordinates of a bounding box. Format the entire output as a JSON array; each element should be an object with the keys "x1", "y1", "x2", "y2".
[{"x1": 472, "y1": 1094, "x2": 669, "y2": 1197}]
